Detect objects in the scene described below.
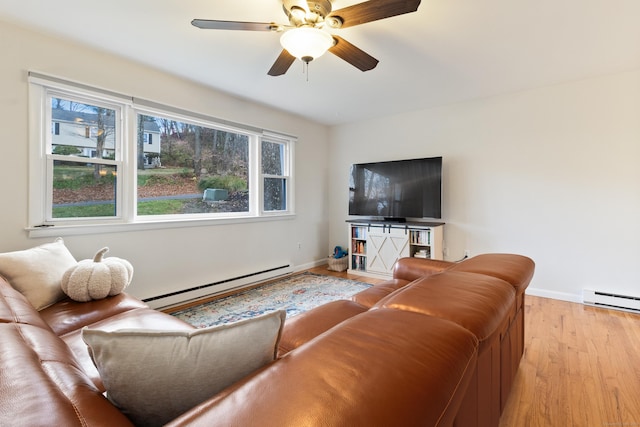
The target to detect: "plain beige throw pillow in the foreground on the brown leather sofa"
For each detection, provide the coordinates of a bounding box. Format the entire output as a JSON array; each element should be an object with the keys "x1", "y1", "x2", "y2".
[{"x1": 82, "y1": 310, "x2": 286, "y2": 426}]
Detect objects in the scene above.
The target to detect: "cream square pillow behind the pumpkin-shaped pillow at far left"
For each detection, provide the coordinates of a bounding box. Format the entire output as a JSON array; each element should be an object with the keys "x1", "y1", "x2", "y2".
[{"x1": 0, "y1": 237, "x2": 77, "y2": 310}]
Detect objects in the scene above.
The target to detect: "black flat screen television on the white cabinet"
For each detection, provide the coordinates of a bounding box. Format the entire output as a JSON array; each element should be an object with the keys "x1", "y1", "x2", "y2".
[{"x1": 349, "y1": 157, "x2": 442, "y2": 221}]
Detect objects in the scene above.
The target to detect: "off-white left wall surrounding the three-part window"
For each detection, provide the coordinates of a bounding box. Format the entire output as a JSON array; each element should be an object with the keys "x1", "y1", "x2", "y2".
[{"x1": 0, "y1": 22, "x2": 331, "y2": 304}]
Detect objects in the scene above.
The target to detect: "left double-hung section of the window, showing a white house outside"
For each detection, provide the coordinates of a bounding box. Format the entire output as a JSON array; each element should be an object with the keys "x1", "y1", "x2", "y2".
[{"x1": 45, "y1": 96, "x2": 121, "y2": 221}]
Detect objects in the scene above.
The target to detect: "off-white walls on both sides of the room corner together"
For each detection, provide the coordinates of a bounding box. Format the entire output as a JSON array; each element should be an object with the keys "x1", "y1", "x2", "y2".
[{"x1": 0, "y1": 23, "x2": 640, "y2": 308}]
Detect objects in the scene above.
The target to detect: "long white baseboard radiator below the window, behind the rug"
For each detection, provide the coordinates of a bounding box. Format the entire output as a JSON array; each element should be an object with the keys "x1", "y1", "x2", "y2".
[{"x1": 142, "y1": 264, "x2": 293, "y2": 309}]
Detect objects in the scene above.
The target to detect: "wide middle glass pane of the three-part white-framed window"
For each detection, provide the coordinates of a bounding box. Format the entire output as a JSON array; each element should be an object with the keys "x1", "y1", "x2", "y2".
[{"x1": 137, "y1": 114, "x2": 250, "y2": 216}]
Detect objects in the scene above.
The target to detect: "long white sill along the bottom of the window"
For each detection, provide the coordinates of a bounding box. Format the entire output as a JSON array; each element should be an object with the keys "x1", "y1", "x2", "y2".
[{"x1": 25, "y1": 213, "x2": 296, "y2": 238}]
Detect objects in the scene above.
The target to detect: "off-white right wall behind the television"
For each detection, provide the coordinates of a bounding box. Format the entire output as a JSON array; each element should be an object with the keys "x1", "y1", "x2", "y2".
[{"x1": 329, "y1": 70, "x2": 640, "y2": 301}]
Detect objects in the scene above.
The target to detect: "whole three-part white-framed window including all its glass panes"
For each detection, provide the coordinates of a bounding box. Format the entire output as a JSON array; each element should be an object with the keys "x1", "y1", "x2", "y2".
[{"x1": 29, "y1": 73, "x2": 295, "y2": 234}]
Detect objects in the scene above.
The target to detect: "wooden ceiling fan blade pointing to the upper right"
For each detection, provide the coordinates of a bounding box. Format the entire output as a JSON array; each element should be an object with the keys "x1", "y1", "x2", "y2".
[{"x1": 329, "y1": 0, "x2": 420, "y2": 28}]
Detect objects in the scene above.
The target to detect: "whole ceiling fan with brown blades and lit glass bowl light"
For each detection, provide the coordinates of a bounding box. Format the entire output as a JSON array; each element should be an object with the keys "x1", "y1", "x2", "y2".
[{"x1": 191, "y1": 0, "x2": 421, "y2": 76}]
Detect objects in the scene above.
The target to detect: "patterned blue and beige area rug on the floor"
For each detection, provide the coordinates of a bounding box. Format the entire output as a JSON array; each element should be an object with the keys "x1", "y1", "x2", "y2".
[{"x1": 172, "y1": 273, "x2": 371, "y2": 328}]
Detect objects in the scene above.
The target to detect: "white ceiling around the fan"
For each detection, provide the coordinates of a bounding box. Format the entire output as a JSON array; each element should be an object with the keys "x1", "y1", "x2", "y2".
[{"x1": 0, "y1": 0, "x2": 640, "y2": 125}]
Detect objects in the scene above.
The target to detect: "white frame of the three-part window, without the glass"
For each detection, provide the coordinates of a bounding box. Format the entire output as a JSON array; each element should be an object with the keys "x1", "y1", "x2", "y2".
[{"x1": 26, "y1": 73, "x2": 296, "y2": 237}]
